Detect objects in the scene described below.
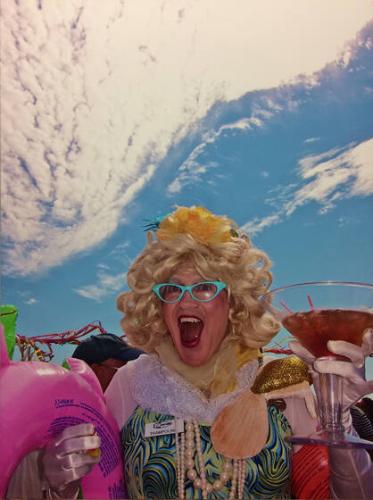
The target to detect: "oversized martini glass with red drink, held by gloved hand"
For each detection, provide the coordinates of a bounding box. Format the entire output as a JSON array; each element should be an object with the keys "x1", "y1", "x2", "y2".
[{"x1": 262, "y1": 281, "x2": 373, "y2": 449}]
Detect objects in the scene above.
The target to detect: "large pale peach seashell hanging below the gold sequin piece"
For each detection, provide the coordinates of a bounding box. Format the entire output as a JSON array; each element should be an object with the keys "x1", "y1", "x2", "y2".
[{"x1": 211, "y1": 391, "x2": 268, "y2": 459}]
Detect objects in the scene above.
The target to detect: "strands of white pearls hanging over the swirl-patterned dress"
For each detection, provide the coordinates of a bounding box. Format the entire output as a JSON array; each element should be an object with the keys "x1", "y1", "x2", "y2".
[{"x1": 175, "y1": 420, "x2": 246, "y2": 500}]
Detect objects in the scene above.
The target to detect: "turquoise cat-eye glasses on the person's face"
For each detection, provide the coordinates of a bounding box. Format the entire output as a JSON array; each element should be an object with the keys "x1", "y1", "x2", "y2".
[{"x1": 152, "y1": 281, "x2": 227, "y2": 304}]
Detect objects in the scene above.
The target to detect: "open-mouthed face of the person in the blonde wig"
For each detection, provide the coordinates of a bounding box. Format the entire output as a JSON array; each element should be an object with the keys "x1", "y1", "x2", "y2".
[{"x1": 162, "y1": 268, "x2": 229, "y2": 366}]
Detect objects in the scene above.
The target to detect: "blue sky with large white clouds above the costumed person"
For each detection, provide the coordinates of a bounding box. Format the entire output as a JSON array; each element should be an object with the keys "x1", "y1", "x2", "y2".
[{"x1": 1, "y1": 0, "x2": 373, "y2": 374}]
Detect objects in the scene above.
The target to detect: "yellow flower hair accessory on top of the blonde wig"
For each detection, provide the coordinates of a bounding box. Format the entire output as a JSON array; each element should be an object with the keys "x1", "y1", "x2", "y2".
[{"x1": 157, "y1": 207, "x2": 238, "y2": 245}]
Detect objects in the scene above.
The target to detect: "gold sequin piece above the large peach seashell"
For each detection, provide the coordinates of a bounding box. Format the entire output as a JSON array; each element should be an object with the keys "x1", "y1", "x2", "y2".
[{"x1": 251, "y1": 356, "x2": 312, "y2": 394}]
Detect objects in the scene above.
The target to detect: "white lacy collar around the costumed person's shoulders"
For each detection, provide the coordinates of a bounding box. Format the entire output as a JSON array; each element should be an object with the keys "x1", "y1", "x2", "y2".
[{"x1": 129, "y1": 355, "x2": 258, "y2": 424}]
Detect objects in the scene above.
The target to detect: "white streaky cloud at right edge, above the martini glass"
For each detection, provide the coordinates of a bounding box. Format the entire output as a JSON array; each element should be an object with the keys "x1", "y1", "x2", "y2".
[{"x1": 241, "y1": 138, "x2": 373, "y2": 235}]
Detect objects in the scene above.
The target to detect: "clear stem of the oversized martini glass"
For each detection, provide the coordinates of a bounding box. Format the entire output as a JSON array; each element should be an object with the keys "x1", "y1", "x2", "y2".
[{"x1": 318, "y1": 373, "x2": 344, "y2": 434}]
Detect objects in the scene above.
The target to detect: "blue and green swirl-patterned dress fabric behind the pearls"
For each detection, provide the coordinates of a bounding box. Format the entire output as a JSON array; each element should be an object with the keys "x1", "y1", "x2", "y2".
[{"x1": 121, "y1": 406, "x2": 291, "y2": 499}]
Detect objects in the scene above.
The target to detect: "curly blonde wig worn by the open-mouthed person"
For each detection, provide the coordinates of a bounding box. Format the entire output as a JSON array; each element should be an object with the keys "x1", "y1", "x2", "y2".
[{"x1": 117, "y1": 207, "x2": 280, "y2": 352}]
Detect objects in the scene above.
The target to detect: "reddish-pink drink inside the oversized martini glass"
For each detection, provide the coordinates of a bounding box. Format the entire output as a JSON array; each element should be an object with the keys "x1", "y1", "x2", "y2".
[{"x1": 282, "y1": 309, "x2": 373, "y2": 358}]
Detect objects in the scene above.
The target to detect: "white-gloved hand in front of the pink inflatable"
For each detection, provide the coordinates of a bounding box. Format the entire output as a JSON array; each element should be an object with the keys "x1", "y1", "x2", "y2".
[{"x1": 41, "y1": 424, "x2": 101, "y2": 497}]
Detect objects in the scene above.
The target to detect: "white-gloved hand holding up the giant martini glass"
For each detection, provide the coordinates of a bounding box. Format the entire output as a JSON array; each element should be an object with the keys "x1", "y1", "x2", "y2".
[{"x1": 289, "y1": 329, "x2": 373, "y2": 423}]
